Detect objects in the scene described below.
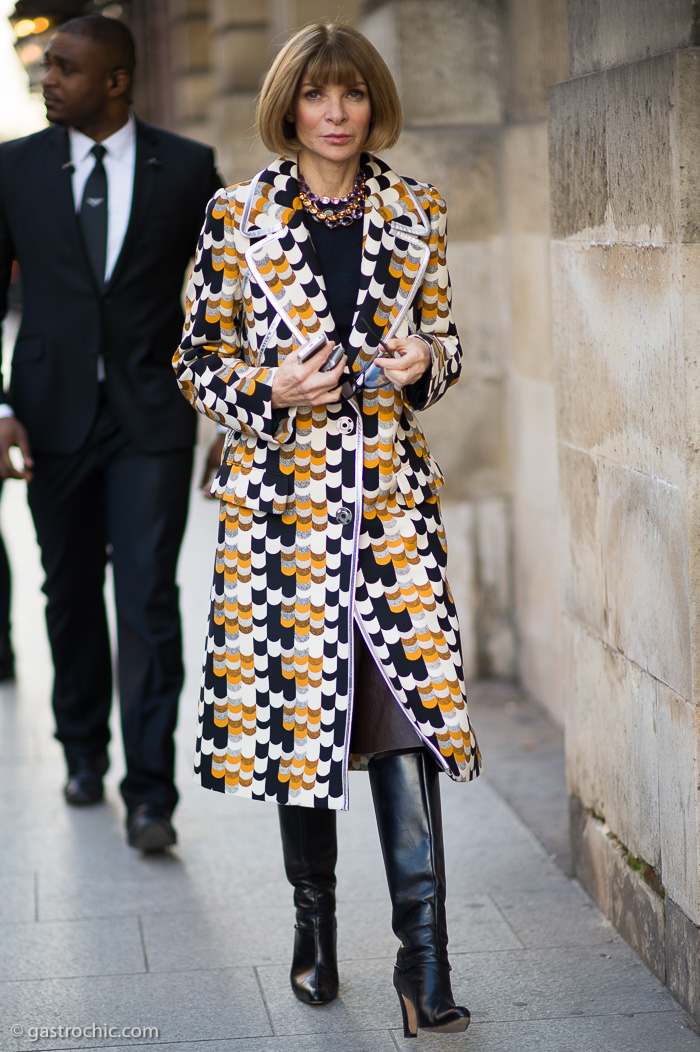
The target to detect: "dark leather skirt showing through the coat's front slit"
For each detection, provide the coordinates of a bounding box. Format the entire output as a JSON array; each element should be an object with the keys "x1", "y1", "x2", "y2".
[{"x1": 351, "y1": 626, "x2": 416, "y2": 755}]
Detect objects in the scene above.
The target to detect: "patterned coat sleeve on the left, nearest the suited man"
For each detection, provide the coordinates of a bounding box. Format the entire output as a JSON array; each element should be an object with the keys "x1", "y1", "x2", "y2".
[{"x1": 173, "y1": 190, "x2": 294, "y2": 443}]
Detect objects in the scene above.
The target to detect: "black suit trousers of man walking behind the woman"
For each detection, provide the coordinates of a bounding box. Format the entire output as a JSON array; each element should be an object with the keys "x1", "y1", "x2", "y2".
[{"x1": 28, "y1": 396, "x2": 193, "y2": 811}]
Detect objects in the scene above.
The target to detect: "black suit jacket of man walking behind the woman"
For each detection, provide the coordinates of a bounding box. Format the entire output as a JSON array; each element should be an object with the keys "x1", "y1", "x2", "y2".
[{"x1": 0, "y1": 120, "x2": 222, "y2": 453}]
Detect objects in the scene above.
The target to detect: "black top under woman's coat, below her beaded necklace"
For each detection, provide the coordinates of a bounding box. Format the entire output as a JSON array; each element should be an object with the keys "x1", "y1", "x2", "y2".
[{"x1": 303, "y1": 211, "x2": 362, "y2": 348}]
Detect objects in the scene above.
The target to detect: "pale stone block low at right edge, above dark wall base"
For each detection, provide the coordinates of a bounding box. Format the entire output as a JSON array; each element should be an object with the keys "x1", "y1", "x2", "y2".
[{"x1": 657, "y1": 684, "x2": 700, "y2": 925}]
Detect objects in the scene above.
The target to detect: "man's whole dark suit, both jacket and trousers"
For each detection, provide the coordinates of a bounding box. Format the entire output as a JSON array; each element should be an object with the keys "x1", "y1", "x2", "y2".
[{"x1": 0, "y1": 121, "x2": 221, "y2": 810}]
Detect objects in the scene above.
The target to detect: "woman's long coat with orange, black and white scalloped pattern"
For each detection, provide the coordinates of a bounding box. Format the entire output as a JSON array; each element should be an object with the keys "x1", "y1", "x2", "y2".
[{"x1": 174, "y1": 157, "x2": 480, "y2": 809}]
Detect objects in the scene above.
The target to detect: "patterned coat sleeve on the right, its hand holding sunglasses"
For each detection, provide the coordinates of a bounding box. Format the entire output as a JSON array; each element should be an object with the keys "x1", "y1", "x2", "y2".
[{"x1": 404, "y1": 186, "x2": 462, "y2": 409}]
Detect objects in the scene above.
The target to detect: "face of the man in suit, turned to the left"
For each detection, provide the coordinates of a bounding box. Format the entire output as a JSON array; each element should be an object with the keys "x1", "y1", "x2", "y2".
[{"x1": 41, "y1": 33, "x2": 112, "y2": 130}]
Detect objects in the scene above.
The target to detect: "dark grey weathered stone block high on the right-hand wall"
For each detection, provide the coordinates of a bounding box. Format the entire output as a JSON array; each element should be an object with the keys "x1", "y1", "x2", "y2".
[{"x1": 549, "y1": 52, "x2": 700, "y2": 244}]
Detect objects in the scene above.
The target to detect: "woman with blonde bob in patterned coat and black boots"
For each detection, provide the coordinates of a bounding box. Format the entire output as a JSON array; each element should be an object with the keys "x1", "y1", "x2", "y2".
[{"x1": 174, "y1": 24, "x2": 480, "y2": 1036}]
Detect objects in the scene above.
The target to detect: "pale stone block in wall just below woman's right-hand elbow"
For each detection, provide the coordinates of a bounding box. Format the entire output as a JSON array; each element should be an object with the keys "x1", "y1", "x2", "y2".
[{"x1": 420, "y1": 380, "x2": 507, "y2": 501}]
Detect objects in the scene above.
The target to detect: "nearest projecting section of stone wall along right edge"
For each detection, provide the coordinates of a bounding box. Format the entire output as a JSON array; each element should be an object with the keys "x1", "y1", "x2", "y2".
[{"x1": 549, "y1": 0, "x2": 700, "y2": 1017}]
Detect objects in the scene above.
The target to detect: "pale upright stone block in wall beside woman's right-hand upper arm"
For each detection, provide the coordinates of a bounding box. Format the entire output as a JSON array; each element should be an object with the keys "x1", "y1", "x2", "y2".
[{"x1": 447, "y1": 238, "x2": 506, "y2": 383}]
